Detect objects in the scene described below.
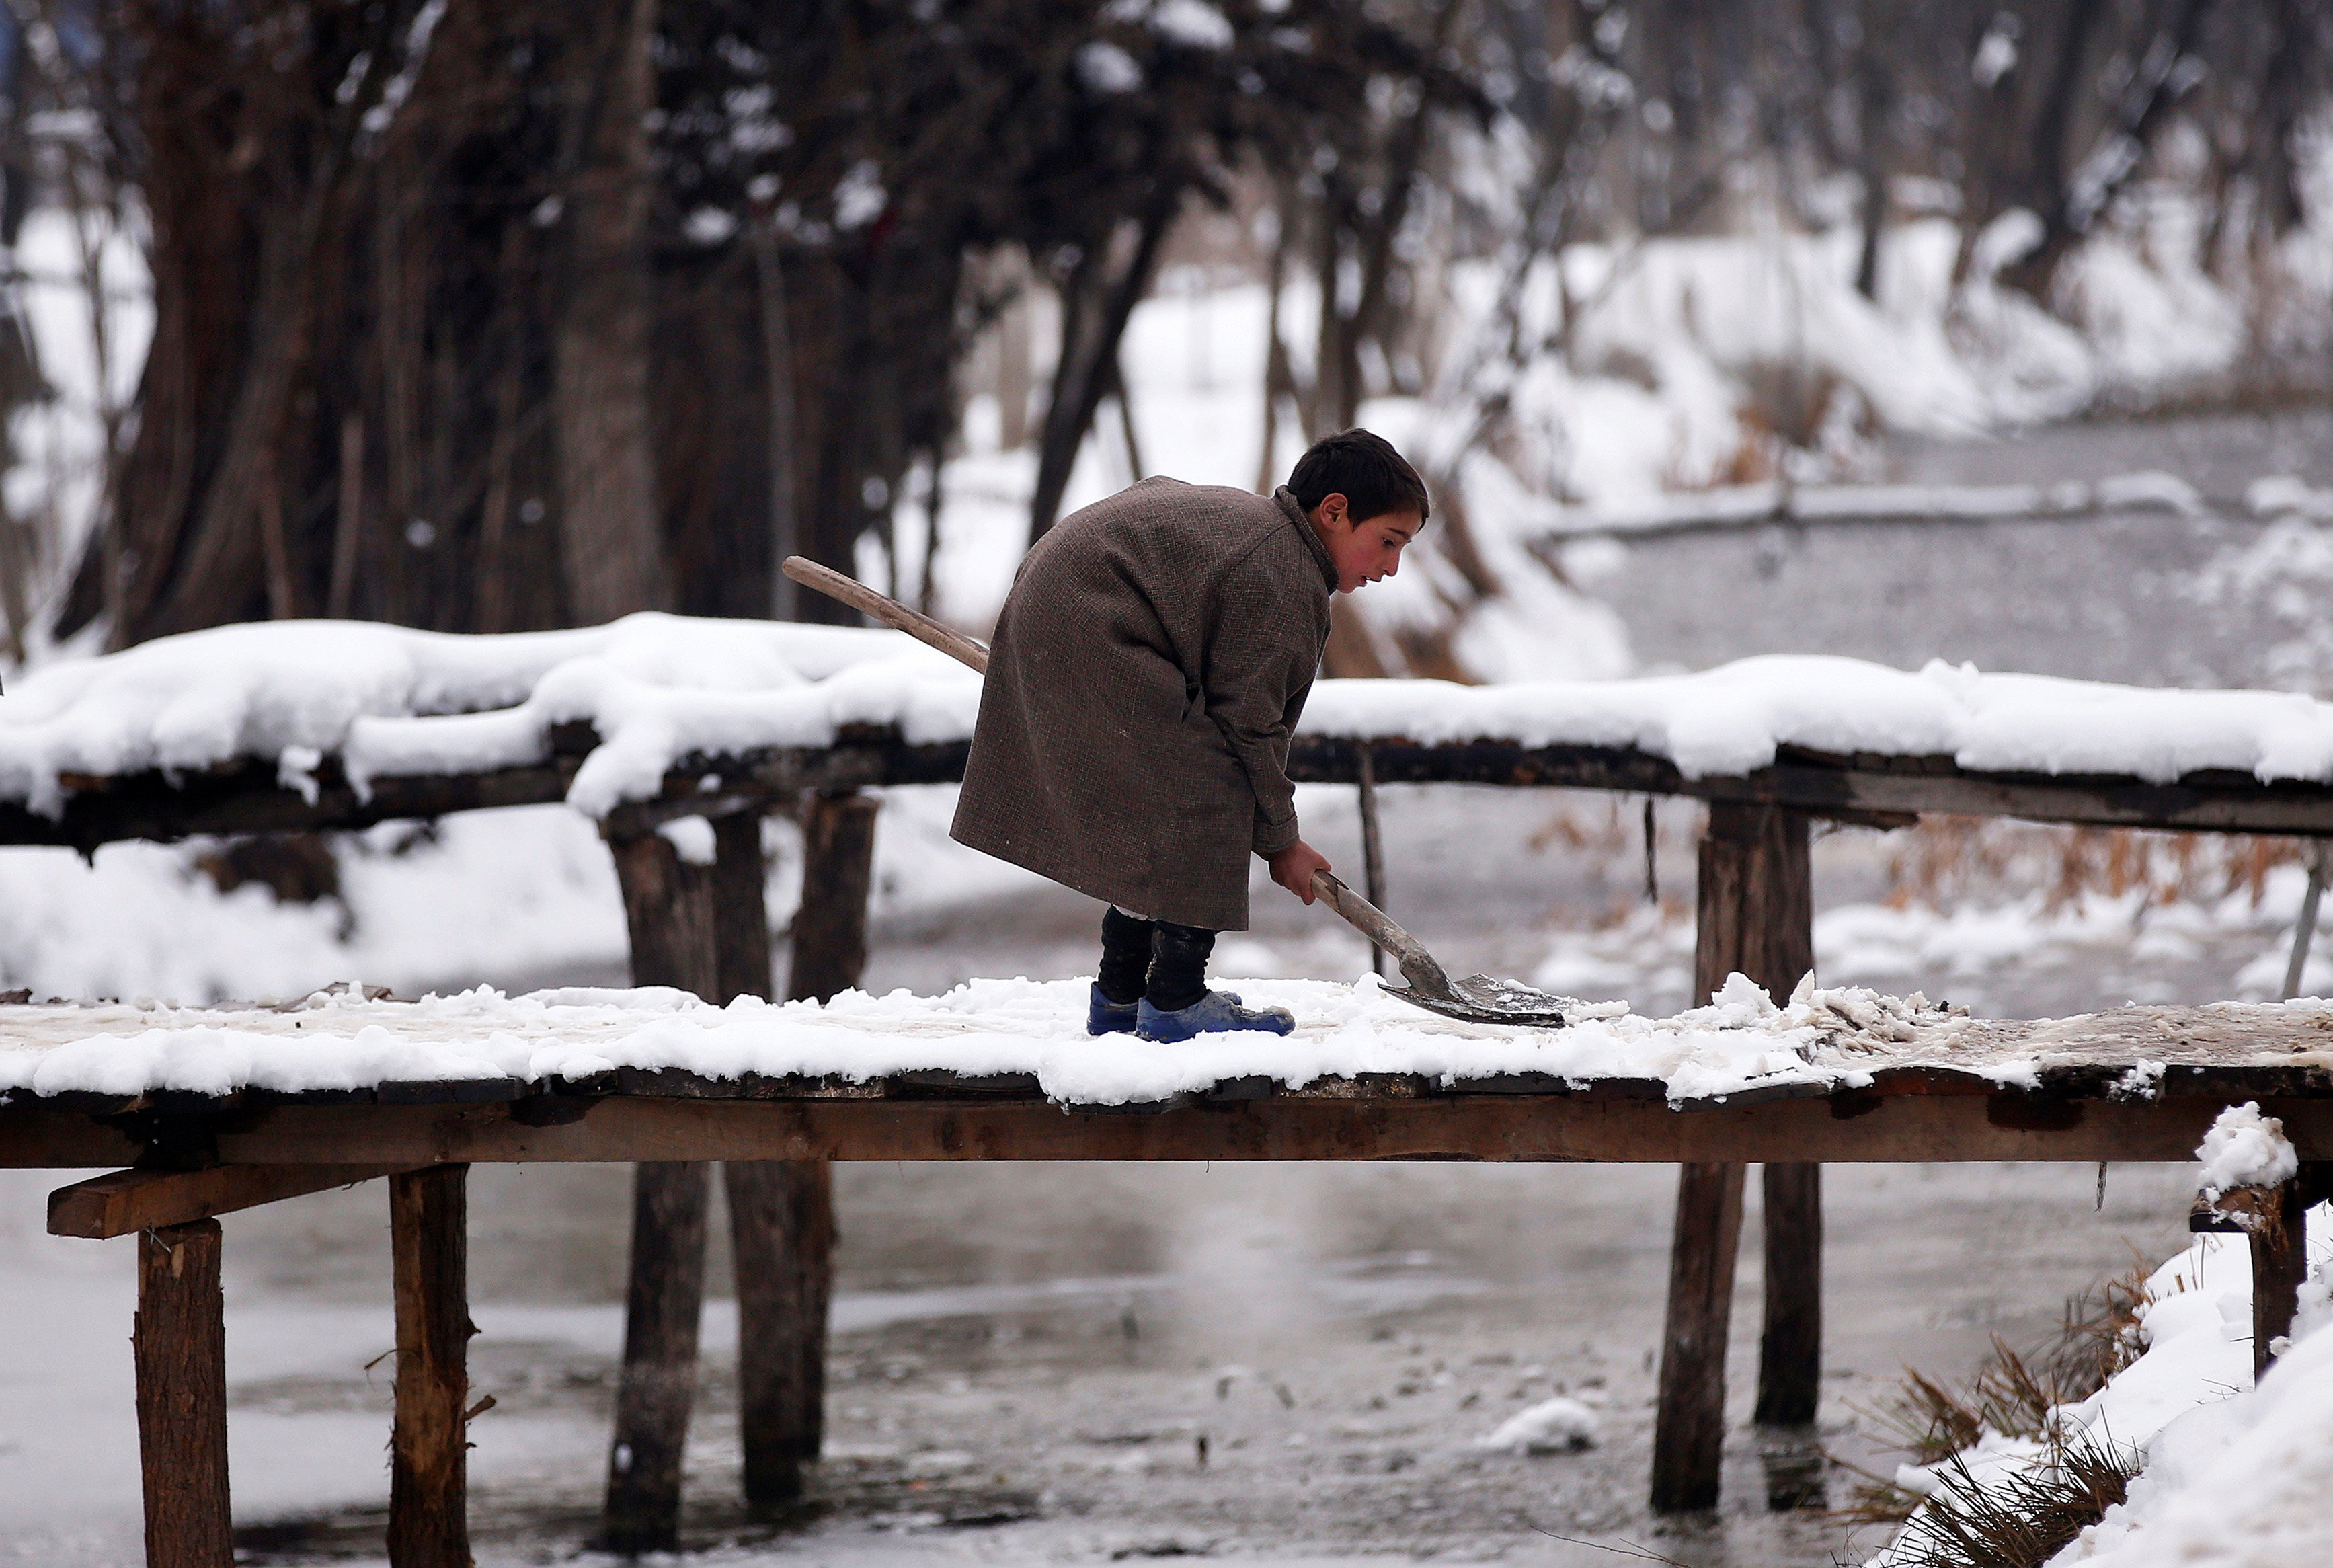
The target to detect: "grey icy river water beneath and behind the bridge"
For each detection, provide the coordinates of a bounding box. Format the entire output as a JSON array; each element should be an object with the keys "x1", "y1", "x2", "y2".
[{"x1": 0, "y1": 413, "x2": 2333, "y2": 1568}]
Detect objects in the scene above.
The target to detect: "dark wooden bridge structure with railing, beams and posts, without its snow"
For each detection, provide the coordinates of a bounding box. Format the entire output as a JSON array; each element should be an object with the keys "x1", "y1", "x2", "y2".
[{"x1": 13, "y1": 634, "x2": 2333, "y2": 1568}]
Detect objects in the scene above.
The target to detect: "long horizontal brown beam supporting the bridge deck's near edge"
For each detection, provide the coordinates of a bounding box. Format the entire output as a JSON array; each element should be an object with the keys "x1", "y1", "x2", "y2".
[{"x1": 141, "y1": 1092, "x2": 2333, "y2": 1165}]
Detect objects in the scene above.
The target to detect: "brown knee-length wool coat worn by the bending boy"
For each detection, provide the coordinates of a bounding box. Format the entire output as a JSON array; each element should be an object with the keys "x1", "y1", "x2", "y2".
[{"x1": 949, "y1": 478, "x2": 1337, "y2": 931}]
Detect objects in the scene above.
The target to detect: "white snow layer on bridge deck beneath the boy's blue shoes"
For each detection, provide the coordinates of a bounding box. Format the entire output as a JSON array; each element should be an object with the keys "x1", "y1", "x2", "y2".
[{"x1": 0, "y1": 976, "x2": 1950, "y2": 1106}]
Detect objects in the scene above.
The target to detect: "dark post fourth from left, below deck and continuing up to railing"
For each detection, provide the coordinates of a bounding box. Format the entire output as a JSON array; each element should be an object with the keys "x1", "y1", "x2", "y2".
[{"x1": 721, "y1": 793, "x2": 879, "y2": 1517}]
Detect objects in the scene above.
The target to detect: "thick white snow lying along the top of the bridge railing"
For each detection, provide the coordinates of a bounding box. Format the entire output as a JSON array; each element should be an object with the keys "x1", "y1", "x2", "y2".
[{"x1": 0, "y1": 614, "x2": 2333, "y2": 817}]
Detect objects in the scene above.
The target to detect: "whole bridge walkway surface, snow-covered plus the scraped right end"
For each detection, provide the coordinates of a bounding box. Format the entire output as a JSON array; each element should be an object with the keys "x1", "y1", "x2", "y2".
[{"x1": 0, "y1": 976, "x2": 2333, "y2": 1134}]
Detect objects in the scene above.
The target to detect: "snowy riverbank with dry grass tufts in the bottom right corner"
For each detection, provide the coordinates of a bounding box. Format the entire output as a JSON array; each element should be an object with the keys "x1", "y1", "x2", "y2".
[{"x1": 1868, "y1": 1213, "x2": 2333, "y2": 1568}]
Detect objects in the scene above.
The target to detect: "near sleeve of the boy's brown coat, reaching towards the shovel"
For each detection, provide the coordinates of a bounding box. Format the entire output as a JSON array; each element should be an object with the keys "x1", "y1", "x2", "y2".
[{"x1": 1206, "y1": 539, "x2": 1320, "y2": 854}]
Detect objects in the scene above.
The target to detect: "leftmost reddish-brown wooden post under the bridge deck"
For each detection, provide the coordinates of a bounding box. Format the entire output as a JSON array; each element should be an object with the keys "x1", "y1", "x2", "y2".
[{"x1": 130, "y1": 1220, "x2": 235, "y2": 1568}]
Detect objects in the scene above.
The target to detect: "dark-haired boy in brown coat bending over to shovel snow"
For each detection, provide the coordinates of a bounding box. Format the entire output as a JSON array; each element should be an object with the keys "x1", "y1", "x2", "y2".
[{"x1": 949, "y1": 430, "x2": 1430, "y2": 1041}]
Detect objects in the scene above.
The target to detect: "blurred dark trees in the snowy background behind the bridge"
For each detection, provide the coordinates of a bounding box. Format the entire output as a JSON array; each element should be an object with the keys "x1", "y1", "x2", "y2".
[{"x1": 0, "y1": 0, "x2": 2333, "y2": 653}]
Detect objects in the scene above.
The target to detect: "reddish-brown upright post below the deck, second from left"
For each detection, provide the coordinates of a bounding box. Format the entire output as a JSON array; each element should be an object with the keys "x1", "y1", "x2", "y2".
[{"x1": 389, "y1": 1165, "x2": 478, "y2": 1568}]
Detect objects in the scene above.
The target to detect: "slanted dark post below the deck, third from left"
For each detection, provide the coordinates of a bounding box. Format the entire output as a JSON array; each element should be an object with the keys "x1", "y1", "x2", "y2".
[{"x1": 600, "y1": 1160, "x2": 709, "y2": 1554}]
